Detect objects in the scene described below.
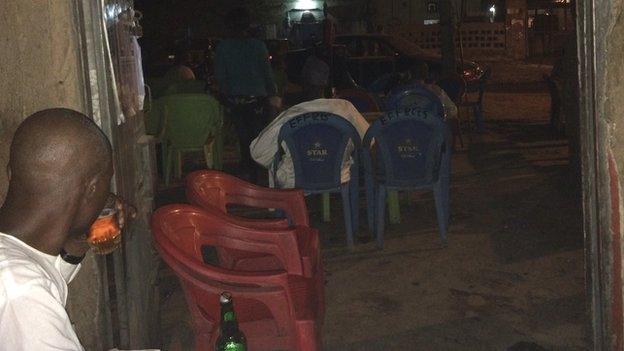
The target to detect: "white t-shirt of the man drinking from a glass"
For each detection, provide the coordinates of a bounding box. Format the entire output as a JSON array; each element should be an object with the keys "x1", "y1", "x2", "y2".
[{"x1": 0, "y1": 233, "x2": 84, "y2": 351}]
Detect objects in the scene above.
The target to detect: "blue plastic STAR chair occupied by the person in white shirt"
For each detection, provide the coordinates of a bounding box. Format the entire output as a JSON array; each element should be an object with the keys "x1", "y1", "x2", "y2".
[{"x1": 273, "y1": 112, "x2": 361, "y2": 248}]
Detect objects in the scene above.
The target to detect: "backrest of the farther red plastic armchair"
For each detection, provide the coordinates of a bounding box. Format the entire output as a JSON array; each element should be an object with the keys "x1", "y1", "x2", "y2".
[{"x1": 186, "y1": 170, "x2": 310, "y2": 227}]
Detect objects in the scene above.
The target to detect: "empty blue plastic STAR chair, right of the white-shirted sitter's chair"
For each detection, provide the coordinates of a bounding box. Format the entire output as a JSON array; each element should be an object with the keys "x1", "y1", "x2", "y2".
[{"x1": 362, "y1": 108, "x2": 451, "y2": 248}]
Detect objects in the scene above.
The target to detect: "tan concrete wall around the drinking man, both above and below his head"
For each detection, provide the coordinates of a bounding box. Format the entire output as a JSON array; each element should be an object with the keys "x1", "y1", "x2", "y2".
[{"x1": 0, "y1": 0, "x2": 107, "y2": 350}]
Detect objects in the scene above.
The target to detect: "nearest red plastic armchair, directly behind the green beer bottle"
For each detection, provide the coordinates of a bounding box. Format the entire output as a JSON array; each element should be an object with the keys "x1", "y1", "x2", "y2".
[{"x1": 152, "y1": 205, "x2": 321, "y2": 351}]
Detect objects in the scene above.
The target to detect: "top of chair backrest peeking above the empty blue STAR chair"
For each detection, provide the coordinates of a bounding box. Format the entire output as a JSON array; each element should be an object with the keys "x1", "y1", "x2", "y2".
[{"x1": 385, "y1": 83, "x2": 444, "y2": 117}]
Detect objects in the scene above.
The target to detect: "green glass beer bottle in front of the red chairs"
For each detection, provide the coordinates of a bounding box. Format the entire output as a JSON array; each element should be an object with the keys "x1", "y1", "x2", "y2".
[{"x1": 215, "y1": 292, "x2": 247, "y2": 351}]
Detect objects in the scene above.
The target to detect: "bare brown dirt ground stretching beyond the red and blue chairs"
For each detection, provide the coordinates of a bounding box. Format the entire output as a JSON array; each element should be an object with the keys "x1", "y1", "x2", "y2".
[{"x1": 160, "y1": 62, "x2": 589, "y2": 351}]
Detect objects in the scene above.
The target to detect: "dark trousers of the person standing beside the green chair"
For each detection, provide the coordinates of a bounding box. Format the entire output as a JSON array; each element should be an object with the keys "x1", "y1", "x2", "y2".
[{"x1": 228, "y1": 97, "x2": 267, "y2": 184}]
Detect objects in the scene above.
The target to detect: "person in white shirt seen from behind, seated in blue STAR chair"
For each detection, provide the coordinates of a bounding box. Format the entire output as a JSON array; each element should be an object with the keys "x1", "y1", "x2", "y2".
[{"x1": 249, "y1": 99, "x2": 368, "y2": 188}]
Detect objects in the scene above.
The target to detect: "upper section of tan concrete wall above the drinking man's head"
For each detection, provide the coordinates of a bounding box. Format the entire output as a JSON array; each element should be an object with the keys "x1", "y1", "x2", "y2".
[{"x1": 0, "y1": 0, "x2": 85, "y2": 198}]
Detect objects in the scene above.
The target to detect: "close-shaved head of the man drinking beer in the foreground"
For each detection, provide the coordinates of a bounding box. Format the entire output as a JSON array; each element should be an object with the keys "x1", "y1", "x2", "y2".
[{"x1": 2, "y1": 108, "x2": 113, "y2": 240}]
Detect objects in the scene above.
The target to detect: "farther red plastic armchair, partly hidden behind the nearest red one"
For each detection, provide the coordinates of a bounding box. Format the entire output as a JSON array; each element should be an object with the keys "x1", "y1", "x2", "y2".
[{"x1": 186, "y1": 170, "x2": 322, "y2": 277}]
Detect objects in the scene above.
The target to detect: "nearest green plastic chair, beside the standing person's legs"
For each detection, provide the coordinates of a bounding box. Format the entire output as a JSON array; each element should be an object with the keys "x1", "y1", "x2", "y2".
[{"x1": 160, "y1": 94, "x2": 223, "y2": 185}]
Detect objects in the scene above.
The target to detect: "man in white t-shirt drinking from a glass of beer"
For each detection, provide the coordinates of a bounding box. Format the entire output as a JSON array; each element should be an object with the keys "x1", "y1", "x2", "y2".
[{"x1": 0, "y1": 109, "x2": 113, "y2": 351}]
